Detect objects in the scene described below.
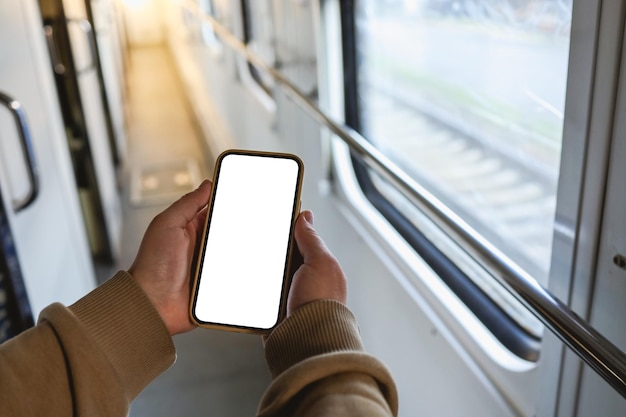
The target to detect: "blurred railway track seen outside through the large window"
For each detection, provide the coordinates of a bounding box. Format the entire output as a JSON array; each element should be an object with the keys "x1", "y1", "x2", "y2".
[{"x1": 365, "y1": 89, "x2": 556, "y2": 280}]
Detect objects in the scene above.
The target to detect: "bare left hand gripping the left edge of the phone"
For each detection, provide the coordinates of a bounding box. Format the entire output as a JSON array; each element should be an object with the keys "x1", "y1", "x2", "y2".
[{"x1": 128, "y1": 180, "x2": 211, "y2": 335}]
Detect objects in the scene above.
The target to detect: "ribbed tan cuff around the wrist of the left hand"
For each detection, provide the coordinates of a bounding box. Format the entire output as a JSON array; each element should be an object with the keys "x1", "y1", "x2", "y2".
[{"x1": 70, "y1": 271, "x2": 176, "y2": 400}]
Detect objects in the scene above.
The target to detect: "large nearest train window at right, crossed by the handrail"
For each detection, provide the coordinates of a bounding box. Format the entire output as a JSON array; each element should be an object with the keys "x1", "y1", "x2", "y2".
[{"x1": 341, "y1": 0, "x2": 572, "y2": 358}]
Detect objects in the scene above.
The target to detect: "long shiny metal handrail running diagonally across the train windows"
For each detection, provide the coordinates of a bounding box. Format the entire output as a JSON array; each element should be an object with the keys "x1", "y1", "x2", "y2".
[{"x1": 185, "y1": 2, "x2": 626, "y2": 398}]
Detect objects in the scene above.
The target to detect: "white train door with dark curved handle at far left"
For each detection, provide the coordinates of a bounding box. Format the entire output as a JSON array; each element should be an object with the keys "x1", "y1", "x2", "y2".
[{"x1": 0, "y1": 1, "x2": 95, "y2": 317}]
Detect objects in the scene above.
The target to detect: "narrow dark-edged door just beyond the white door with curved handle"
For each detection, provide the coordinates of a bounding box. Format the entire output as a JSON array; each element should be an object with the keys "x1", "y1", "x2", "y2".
[{"x1": 39, "y1": 0, "x2": 121, "y2": 261}]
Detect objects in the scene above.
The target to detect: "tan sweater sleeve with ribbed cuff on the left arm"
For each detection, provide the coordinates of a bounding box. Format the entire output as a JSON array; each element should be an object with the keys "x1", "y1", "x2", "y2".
[{"x1": 0, "y1": 272, "x2": 175, "y2": 417}]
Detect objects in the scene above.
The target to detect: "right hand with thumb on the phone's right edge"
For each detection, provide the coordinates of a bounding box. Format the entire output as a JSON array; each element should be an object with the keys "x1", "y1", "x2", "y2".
[{"x1": 287, "y1": 211, "x2": 347, "y2": 317}]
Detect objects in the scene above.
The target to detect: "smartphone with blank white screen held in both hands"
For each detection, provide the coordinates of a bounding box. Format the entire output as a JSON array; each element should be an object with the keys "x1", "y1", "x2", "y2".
[{"x1": 191, "y1": 150, "x2": 304, "y2": 333}]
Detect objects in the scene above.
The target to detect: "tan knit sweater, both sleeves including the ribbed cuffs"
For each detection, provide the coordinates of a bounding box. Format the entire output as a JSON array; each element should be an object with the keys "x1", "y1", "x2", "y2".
[{"x1": 0, "y1": 271, "x2": 398, "y2": 417}]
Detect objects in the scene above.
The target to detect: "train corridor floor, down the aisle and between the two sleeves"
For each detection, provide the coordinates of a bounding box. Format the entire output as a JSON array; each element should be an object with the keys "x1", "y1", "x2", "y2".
[{"x1": 98, "y1": 47, "x2": 269, "y2": 417}]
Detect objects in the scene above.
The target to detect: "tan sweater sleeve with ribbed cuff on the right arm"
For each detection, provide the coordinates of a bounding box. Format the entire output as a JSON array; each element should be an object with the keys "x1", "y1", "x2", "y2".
[{"x1": 259, "y1": 300, "x2": 398, "y2": 417}]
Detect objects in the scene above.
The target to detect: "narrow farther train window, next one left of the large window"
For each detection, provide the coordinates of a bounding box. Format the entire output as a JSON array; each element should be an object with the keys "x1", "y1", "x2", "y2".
[{"x1": 241, "y1": 0, "x2": 276, "y2": 95}]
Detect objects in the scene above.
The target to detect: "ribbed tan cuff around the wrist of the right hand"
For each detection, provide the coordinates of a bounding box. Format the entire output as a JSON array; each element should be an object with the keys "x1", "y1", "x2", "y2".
[{"x1": 265, "y1": 300, "x2": 364, "y2": 378}]
